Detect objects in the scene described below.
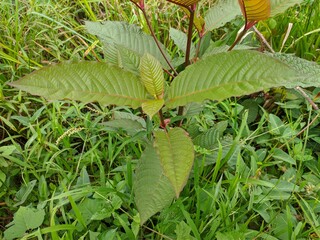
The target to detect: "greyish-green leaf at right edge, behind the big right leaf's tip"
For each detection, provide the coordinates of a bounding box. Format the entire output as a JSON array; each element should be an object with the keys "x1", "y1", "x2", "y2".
[{"x1": 269, "y1": 53, "x2": 320, "y2": 87}]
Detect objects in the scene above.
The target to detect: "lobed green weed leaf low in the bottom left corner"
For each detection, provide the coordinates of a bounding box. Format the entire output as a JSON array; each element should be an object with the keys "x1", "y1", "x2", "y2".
[{"x1": 4, "y1": 207, "x2": 45, "y2": 240}]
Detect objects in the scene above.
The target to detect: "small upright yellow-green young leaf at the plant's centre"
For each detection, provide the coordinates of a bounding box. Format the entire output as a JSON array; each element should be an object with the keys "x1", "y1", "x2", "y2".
[{"x1": 140, "y1": 53, "x2": 164, "y2": 99}]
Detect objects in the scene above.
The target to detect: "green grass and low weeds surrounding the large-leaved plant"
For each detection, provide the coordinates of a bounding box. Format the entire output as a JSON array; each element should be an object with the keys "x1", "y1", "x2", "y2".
[{"x1": 0, "y1": 0, "x2": 320, "y2": 240}]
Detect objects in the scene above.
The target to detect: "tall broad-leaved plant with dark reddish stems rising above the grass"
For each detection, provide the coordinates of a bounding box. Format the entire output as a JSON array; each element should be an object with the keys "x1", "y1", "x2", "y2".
[{"x1": 10, "y1": 0, "x2": 320, "y2": 224}]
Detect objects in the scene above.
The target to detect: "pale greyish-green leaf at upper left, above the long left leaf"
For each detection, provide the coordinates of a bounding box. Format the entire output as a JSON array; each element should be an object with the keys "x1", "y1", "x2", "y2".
[{"x1": 86, "y1": 21, "x2": 170, "y2": 68}]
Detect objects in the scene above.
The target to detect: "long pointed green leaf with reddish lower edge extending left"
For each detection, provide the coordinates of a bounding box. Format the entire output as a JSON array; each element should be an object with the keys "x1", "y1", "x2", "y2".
[{"x1": 10, "y1": 62, "x2": 147, "y2": 108}]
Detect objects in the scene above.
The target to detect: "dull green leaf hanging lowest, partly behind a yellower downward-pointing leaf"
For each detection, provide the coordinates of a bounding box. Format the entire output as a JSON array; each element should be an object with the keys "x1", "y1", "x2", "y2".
[{"x1": 133, "y1": 145, "x2": 175, "y2": 225}]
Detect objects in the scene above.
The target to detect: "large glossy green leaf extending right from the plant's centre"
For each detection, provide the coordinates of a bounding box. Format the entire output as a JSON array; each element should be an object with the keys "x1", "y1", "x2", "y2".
[{"x1": 166, "y1": 50, "x2": 303, "y2": 108}]
